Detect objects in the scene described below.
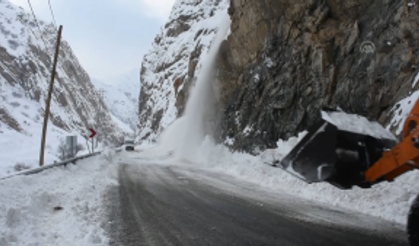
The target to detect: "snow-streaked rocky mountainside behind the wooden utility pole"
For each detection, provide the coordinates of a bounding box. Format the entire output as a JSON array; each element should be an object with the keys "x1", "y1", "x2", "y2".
[{"x1": 0, "y1": 0, "x2": 124, "y2": 175}]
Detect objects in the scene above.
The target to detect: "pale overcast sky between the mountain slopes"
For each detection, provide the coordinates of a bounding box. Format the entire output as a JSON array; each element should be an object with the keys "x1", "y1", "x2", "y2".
[{"x1": 10, "y1": 0, "x2": 175, "y2": 80}]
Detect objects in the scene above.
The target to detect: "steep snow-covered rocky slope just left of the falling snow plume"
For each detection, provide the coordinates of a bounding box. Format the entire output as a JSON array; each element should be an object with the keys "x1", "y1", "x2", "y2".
[{"x1": 138, "y1": 0, "x2": 229, "y2": 140}]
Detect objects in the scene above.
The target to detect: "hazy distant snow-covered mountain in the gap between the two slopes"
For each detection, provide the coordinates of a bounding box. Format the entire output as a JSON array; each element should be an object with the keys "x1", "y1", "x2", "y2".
[{"x1": 92, "y1": 69, "x2": 140, "y2": 131}]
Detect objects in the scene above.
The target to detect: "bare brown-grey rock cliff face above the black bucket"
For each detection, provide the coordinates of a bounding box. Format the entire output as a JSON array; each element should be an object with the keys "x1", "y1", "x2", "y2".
[{"x1": 218, "y1": 0, "x2": 419, "y2": 151}]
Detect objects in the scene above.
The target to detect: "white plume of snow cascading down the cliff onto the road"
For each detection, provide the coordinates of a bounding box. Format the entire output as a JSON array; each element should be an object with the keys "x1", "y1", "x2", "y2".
[{"x1": 156, "y1": 12, "x2": 230, "y2": 162}]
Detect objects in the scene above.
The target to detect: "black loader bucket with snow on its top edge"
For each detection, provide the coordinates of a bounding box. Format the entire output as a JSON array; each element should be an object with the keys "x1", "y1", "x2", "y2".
[{"x1": 280, "y1": 109, "x2": 397, "y2": 189}]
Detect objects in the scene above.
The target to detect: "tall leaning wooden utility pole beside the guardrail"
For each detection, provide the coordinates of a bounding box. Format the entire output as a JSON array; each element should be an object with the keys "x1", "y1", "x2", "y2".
[{"x1": 39, "y1": 25, "x2": 63, "y2": 166}]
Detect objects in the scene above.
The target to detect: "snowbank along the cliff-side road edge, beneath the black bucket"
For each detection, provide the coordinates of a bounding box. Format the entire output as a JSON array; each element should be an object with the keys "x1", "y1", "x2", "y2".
[{"x1": 189, "y1": 134, "x2": 419, "y2": 224}]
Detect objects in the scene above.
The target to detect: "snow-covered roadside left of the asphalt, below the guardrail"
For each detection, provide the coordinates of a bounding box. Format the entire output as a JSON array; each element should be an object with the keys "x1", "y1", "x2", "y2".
[{"x1": 0, "y1": 153, "x2": 117, "y2": 246}]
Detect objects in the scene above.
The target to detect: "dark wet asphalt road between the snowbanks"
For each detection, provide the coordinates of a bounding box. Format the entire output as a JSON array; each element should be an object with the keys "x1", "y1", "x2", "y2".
[{"x1": 107, "y1": 161, "x2": 408, "y2": 246}]
